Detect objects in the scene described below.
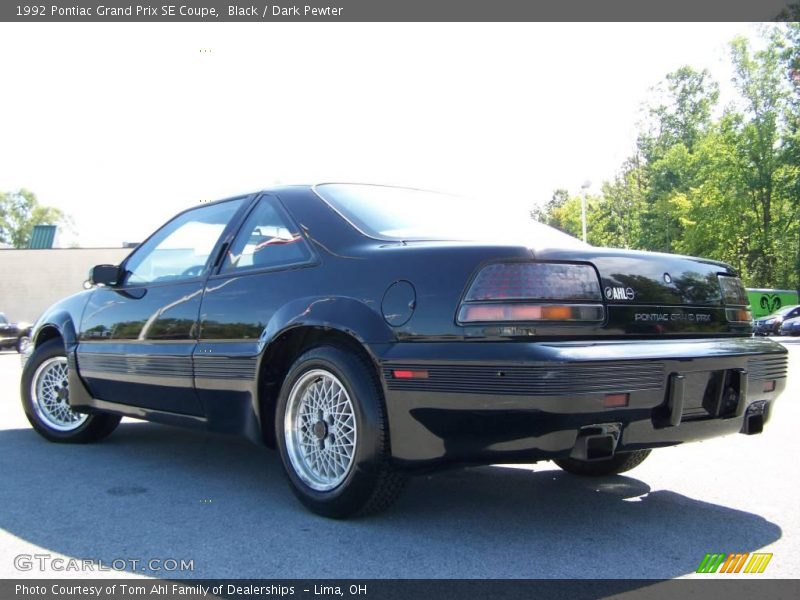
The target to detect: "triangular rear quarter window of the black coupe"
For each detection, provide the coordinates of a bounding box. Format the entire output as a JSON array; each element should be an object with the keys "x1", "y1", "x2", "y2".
[{"x1": 222, "y1": 198, "x2": 311, "y2": 273}]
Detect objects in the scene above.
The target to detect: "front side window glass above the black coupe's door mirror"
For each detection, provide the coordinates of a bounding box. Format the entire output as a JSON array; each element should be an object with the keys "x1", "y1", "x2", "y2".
[{"x1": 125, "y1": 199, "x2": 242, "y2": 285}]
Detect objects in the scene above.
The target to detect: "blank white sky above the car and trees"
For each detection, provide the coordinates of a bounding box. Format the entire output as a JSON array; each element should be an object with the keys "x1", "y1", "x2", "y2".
[{"x1": 0, "y1": 23, "x2": 768, "y2": 246}]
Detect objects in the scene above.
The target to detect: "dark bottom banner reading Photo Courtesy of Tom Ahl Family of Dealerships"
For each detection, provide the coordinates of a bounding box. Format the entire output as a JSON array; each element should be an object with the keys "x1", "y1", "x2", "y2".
[{"x1": 0, "y1": 576, "x2": 800, "y2": 600}]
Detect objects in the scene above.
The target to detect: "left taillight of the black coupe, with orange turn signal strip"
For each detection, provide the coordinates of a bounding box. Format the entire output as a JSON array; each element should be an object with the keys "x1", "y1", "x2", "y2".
[{"x1": 458, "y1": 262, "x2": 605, "y2": 323}]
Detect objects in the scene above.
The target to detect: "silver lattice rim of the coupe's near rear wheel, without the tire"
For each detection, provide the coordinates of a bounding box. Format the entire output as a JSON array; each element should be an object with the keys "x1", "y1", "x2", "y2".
[{"x1": 284, "y1": 369, "x2": 357, "y2": 492}]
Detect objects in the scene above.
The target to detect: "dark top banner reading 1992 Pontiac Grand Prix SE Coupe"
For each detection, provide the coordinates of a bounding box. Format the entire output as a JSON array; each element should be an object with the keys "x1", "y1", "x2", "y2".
[{"x1": 0, "y1": 0, "x2": 800, "y2": 23}]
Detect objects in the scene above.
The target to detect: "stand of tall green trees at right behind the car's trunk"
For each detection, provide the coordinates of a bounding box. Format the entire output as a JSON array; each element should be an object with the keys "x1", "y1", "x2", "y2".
[{"x1": 531, "y1": 23, "x2": 800, "y2": 288}]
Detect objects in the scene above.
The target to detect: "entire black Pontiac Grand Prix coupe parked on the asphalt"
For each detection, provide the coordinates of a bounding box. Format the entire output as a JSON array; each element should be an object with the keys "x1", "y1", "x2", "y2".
[{"x1": 21, "y1": 184, "x2": 787, "y2": 517}]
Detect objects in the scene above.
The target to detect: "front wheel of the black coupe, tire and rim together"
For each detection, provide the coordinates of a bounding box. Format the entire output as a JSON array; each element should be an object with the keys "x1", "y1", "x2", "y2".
[{"x1": 20, "y1": 339, "x2": 120, "y2": 443}]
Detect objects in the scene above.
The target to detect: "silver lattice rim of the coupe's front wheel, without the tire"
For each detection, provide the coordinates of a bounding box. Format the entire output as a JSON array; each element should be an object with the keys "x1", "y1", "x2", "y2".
[{"x1": 31, "y1": 356, "x2": 89, "y2": 432}]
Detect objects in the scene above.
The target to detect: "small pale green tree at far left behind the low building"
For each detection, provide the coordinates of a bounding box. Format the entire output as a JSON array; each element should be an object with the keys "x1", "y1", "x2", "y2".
[{"x1": 0, "y1": 189, "x2": 68, "y2": 248}]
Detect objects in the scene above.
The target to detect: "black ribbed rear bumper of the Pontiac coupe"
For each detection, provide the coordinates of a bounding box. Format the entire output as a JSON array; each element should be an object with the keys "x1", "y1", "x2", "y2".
[{"x1": 379, "y1": 338, "x2": 787, "y2": 467}]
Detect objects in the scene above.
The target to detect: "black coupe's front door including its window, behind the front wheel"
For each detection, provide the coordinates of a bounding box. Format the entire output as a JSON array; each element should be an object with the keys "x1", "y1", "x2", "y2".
[{"x1": 77, "y1": 198, "x2": 246, "y2": 416}]
